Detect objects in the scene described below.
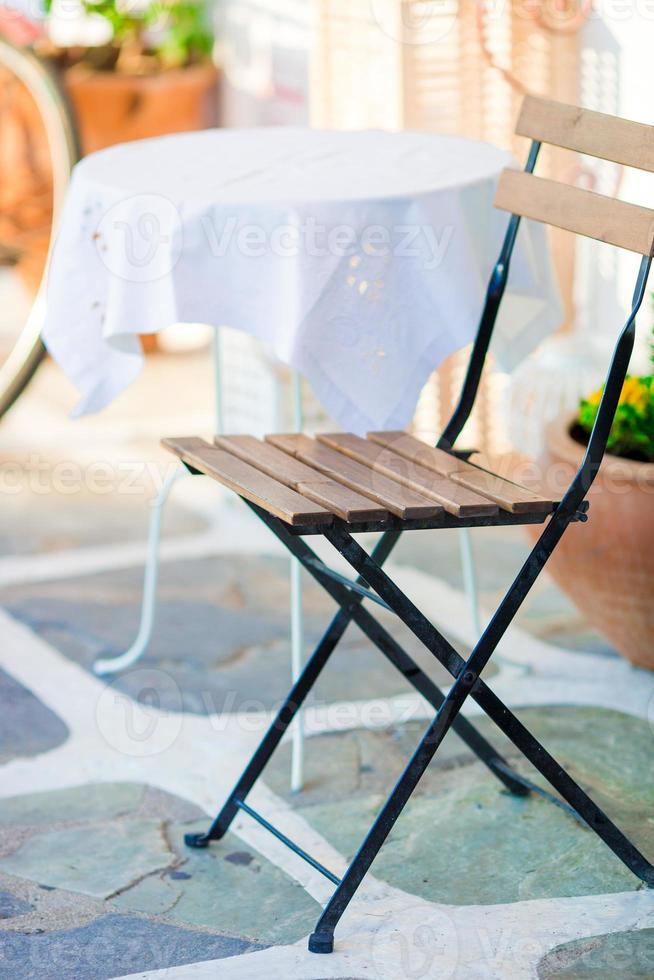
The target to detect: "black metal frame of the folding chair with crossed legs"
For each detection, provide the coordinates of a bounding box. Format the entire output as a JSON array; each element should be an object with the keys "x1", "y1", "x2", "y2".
[{"x1": 181, "y1": 134, "x2": 654, "y2": 953}]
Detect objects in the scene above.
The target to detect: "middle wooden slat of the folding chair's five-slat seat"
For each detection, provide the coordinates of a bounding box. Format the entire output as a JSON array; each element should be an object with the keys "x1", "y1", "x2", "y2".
[{"x1": 266, "y1": 433, "x2": 443, "y2": 520}]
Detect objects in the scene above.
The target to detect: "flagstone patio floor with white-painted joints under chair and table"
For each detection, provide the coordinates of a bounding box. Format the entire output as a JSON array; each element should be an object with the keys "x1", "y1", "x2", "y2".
[{"x1": 0, "y1": 359, "x2": 654, "y2": 980}]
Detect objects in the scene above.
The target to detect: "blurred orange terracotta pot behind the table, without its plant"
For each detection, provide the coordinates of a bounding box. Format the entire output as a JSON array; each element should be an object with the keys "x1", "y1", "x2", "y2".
[{"x1": 64, "y1": 63, "x2": 218, "y2": 153}]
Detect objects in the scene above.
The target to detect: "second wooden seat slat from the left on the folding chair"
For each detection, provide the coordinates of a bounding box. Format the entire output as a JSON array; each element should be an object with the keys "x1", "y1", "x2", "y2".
[{"x1": 214, "y1": 435, "x2": 388, "y2": 523}]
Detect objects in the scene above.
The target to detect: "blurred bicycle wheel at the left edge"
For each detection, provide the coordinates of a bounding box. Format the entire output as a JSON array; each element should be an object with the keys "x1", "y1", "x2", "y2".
[{"x1": 0, "y1": 37, "x2": 79, "y2": 417}]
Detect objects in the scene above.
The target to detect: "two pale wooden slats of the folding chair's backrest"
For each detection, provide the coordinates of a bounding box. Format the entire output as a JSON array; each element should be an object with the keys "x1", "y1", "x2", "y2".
[{"x1": 495, "y1": 96, "x2": 654, "y2": 256}]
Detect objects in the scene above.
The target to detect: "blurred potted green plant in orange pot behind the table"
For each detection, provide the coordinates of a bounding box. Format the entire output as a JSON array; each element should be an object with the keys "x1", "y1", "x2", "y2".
[{"x1": 45, "y1": 0, "x2": 217, "y2": 153}]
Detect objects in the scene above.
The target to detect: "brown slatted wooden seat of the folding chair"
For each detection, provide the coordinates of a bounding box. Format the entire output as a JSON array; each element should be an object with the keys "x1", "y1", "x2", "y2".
[{"x1": 163, "y1": 432, "x2": 555, "y2": 531}]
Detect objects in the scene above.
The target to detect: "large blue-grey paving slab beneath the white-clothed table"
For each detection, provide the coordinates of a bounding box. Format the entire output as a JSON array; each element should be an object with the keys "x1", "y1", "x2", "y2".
[{"x1": 0, "y1": 555, "x2": 482, "y2": 714}]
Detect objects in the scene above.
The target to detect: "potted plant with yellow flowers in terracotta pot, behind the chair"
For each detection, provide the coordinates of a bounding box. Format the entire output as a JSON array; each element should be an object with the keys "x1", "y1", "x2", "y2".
[{"x1": 543, "y1": 326, "x2": 654, "y2": 669}]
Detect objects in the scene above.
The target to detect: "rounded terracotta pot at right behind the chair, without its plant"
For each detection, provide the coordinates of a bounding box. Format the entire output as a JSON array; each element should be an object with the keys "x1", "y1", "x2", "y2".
[{"x1": 532, "y1": 418, "x2": 654, "y2": 669}]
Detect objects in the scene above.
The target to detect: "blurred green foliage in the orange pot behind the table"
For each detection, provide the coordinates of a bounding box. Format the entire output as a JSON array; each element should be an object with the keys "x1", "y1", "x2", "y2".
[{"x1": 46, "y1": 0, "x2": 213, "y2": 74}]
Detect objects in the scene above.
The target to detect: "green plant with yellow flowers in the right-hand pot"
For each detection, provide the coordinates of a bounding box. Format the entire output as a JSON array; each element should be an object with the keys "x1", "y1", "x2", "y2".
[{"x1": 577, "y1": 320, "x2": 654, "y2": 462}]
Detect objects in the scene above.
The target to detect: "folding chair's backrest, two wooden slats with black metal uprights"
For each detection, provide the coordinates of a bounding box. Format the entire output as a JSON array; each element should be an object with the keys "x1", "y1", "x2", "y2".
[{"x1": 438, "y1": 96, "x2": 654, "y2": 517}]
